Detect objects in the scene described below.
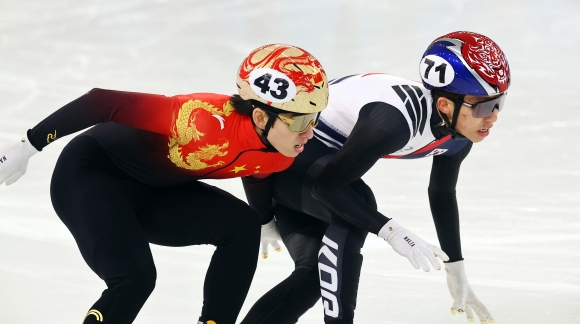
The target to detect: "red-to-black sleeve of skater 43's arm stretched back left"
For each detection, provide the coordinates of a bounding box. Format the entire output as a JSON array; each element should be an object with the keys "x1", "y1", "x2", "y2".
[{"x1": 28, "y1": 89, "x2": 179, "y2": 150}]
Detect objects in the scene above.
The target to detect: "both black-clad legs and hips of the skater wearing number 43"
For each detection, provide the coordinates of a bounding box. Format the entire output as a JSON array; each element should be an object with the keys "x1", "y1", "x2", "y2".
[{"x1": 50, "y1": 135, "x2": 260, "y2": 324}]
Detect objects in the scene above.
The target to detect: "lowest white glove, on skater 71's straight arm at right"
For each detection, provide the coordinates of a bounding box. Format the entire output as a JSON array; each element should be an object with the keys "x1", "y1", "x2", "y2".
[{"x1": 445, "y1": 260, "x2": 495, "y2": 324}]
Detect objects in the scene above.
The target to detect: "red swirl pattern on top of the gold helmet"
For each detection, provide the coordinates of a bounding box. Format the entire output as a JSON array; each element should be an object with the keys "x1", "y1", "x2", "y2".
[{"x1": 240, "y1": 45, "x2": 324, "y2": 93}]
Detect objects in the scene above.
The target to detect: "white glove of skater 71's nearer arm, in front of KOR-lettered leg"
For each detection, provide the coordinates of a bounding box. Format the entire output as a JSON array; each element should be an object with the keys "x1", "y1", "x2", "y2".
[{"x1": 379, "y1": 219, "x2": 449, "y2": 271}]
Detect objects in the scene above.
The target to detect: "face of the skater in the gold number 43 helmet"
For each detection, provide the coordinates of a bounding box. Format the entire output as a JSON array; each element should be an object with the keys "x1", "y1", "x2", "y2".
[{"x1": 254, "y1": 109, "x2": 314, "y2": 157}]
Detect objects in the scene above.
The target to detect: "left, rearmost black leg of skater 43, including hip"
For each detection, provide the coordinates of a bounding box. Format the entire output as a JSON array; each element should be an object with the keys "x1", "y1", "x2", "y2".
[{"x1": 51, "y1": 136, "x2": 156, "y2": 324}]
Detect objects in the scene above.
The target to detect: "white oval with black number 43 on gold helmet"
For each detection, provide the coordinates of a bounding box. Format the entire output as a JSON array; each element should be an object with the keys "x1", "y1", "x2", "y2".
[{"x1": 250, "y1": 68, "x2": 296, "y2": 103}]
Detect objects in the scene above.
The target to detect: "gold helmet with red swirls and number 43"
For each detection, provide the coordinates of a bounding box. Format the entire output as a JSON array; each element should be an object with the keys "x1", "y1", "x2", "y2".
[{"x1": 237, "y1": 44, "x2": 328, "y2": 114}]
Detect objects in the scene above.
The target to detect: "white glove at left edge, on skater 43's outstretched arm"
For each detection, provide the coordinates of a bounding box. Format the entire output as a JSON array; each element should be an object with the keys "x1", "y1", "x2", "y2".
[{"x1": 0, "y1": 136, "x2": 38, "y2": 186}]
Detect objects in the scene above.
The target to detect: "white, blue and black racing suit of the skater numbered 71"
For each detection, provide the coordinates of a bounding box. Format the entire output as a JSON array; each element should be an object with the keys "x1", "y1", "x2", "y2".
[{"x1": 242, "y1": 73, "x2": 472, "y2": 324}]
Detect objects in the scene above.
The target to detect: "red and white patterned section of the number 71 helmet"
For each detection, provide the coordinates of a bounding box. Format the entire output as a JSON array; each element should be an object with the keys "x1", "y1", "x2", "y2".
[{"x1": 441, "y1": 32, "x2": 510, "y2": 92}]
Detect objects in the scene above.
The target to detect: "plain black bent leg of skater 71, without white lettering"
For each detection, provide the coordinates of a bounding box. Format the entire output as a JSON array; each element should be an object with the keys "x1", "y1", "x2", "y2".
[{"x1": 241, "y1": 205, "x2": 328, "y2": 324}]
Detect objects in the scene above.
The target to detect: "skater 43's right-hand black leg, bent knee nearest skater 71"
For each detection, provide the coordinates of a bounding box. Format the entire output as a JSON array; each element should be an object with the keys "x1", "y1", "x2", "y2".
[{"x1": 138, "y1": 182, "x2": 260, "y2": 324}]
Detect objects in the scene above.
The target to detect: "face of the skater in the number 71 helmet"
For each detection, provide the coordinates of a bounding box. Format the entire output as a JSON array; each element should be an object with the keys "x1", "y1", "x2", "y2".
[{"x1": 437, "y1": 96, "x2": 499, "y2": 143}]
